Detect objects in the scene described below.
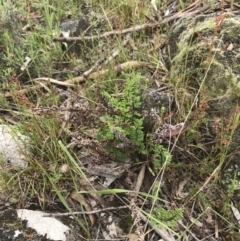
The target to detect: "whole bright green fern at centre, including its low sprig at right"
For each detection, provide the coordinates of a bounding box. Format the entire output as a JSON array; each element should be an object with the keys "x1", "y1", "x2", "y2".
[{"x1": 97, "y1": 73, "x2": 172, "y2": 170}]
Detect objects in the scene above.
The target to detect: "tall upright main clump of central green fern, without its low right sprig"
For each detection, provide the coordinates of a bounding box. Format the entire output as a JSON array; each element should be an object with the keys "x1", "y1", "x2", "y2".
[{"x1": 98, "y1": 73, "x2": 146, "y2": 160}]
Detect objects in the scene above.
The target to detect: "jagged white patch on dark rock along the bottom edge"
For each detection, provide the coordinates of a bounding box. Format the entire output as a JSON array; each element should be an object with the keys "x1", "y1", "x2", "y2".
[{"x1": 17, "y1": 209, "x2": 70, "y2": 241}]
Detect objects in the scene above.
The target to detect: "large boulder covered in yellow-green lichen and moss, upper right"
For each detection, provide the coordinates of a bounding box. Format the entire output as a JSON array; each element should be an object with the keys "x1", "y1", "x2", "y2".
[{"x1": 170, "y1": 15, "x2": 240, "y2": 113}]
